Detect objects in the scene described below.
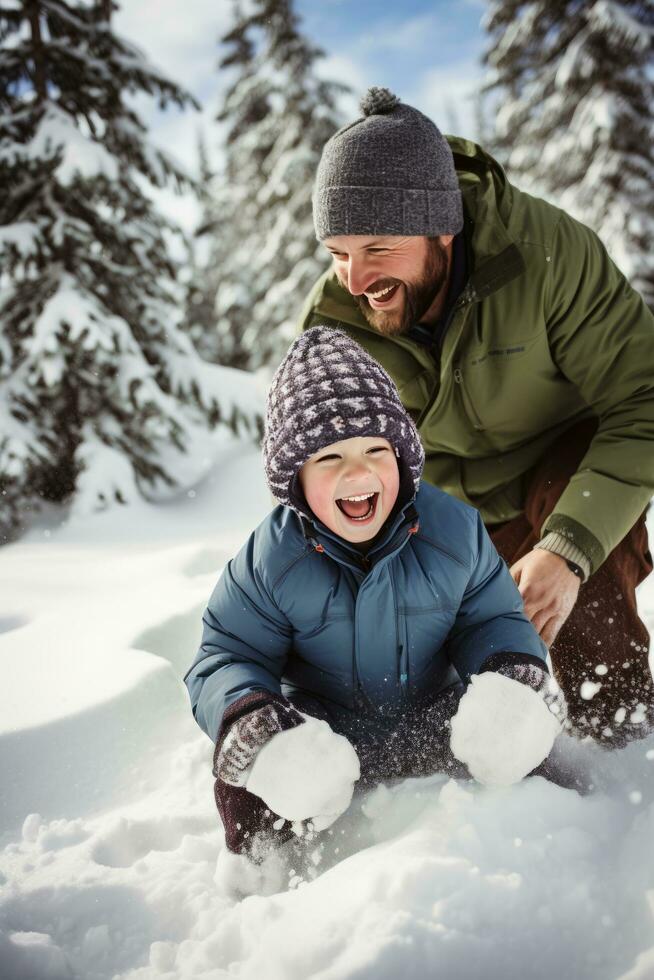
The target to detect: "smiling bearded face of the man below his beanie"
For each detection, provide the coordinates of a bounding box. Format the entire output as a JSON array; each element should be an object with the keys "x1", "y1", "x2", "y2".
[{"x1": 323, "y1": 235, "x2": 453, "y2": 335}]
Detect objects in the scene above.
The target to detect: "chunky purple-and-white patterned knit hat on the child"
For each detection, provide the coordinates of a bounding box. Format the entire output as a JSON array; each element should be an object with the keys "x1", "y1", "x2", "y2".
[{"x1": 263, "y1": 326, "x2": 425, "y2": 517}]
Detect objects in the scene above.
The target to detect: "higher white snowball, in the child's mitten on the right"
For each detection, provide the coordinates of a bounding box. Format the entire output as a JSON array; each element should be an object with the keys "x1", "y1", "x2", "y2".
[{"x1": 450, "y1": 657, "x2": 565, "y2": 786}]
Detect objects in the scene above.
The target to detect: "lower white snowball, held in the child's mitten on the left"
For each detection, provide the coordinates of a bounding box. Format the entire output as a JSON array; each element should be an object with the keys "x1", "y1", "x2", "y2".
[{"x1": 246, "y1": 715, "x2": 360, "y2": 830}]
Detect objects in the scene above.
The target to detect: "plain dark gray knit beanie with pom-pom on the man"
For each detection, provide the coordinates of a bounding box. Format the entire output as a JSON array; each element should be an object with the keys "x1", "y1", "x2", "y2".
[{"x1": 313, "y1": 87, "x2": 463, "y2": 241}]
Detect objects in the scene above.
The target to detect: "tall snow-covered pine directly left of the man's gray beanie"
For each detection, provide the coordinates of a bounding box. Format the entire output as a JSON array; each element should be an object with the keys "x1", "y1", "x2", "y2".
[{"x1": 195, "y1": 0, "x2": 348, "y2": 369}]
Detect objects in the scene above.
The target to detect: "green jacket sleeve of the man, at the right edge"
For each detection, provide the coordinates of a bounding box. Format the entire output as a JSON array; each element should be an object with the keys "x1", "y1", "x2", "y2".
[{"x1": 542, "y1": 214, "x2": 654, "y2": 572}]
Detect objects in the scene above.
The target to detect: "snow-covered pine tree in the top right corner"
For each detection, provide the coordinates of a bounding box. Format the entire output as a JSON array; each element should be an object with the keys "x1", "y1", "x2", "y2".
[{"x1": 485, "y1": 0, "x2": 654, "y2": 308}]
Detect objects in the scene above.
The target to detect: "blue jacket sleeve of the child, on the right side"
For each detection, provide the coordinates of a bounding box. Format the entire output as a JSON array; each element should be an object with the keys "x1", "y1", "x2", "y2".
[{"x1": 447, "y1": 513, "x2": 547, "y2": 683}]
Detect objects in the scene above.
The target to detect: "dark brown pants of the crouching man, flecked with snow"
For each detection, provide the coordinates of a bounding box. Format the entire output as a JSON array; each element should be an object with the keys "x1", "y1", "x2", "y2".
[{"x1": 488, "y1": 421, "x2": 654, "y2": 746}]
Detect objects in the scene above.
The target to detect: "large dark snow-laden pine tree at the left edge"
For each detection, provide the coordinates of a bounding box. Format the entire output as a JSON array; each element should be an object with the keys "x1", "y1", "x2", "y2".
[{"x1": 0, "y1": 0, "x2": 262, "y2": 537}]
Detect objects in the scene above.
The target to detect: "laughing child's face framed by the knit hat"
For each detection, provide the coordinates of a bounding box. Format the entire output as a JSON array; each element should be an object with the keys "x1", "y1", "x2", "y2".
[{"x1": 300, "y1": 436, "x2": 400, "y2": 543}]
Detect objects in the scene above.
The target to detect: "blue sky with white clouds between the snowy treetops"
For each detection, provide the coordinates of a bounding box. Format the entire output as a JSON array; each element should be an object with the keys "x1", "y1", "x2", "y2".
[{"x1": 114, "y1": 0, "x2": 487, "y2": 231}]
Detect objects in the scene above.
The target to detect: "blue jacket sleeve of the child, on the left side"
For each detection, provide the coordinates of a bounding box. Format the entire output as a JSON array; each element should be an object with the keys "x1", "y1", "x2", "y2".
[{"x1": 184, "y1": 531, "x2": 292, "y2": 742}]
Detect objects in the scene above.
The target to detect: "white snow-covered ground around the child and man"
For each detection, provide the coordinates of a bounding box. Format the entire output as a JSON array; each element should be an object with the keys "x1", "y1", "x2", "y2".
[{"x1": 0, "y1": 443, "x2": 654, "y2": 980}]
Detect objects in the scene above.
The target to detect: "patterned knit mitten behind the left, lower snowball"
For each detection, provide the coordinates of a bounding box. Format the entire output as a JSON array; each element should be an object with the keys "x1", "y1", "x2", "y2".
[{"x1": 213, "y1": 701, "x2": 305, "y2": 786}]
